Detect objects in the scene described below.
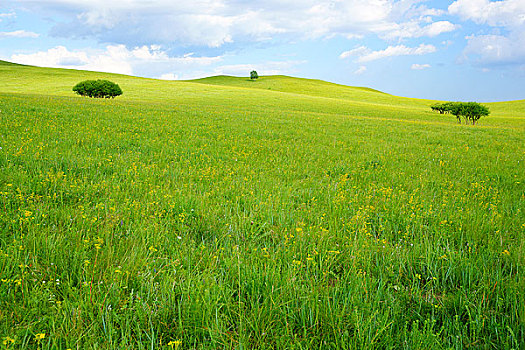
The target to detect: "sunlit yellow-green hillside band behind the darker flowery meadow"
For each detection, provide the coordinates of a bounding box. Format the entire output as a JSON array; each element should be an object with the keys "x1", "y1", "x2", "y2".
[{"x1": 0, "y1": 60, "x2": 525, "y2": 127}]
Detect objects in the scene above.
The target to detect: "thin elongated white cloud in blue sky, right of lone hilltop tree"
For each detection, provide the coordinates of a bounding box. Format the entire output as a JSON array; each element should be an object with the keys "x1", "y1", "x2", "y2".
[{"x1": 339, "y1": 44, "x2": 436, "y2": 63}]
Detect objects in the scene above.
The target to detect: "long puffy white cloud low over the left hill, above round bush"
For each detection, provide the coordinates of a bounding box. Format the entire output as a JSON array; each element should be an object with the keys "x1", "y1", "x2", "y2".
[{"x1": 11, "y1": 45, "x2": 222, "y2": 74}]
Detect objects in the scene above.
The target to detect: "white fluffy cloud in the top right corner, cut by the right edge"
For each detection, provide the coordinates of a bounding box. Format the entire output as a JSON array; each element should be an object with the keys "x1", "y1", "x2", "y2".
[{"x1": 448, "y1": 0, "x2": 525, "y2": 66}]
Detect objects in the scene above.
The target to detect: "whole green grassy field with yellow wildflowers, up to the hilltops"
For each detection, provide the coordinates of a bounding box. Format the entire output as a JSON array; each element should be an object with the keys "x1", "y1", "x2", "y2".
[{"x1": 0, "y1": 61, "x2": 525, "y2": 349}]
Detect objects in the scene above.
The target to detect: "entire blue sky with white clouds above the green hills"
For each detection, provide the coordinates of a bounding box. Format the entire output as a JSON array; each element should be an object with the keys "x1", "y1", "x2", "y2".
[{"x1": 0, "y1": 0, "x2": 525, "y2": 102}]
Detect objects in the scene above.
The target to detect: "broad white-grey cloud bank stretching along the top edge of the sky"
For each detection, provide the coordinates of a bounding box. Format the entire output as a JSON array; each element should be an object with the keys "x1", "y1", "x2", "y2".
[{"x1": 13, "y1": 0, "x2": 455, "y2": 47}]
